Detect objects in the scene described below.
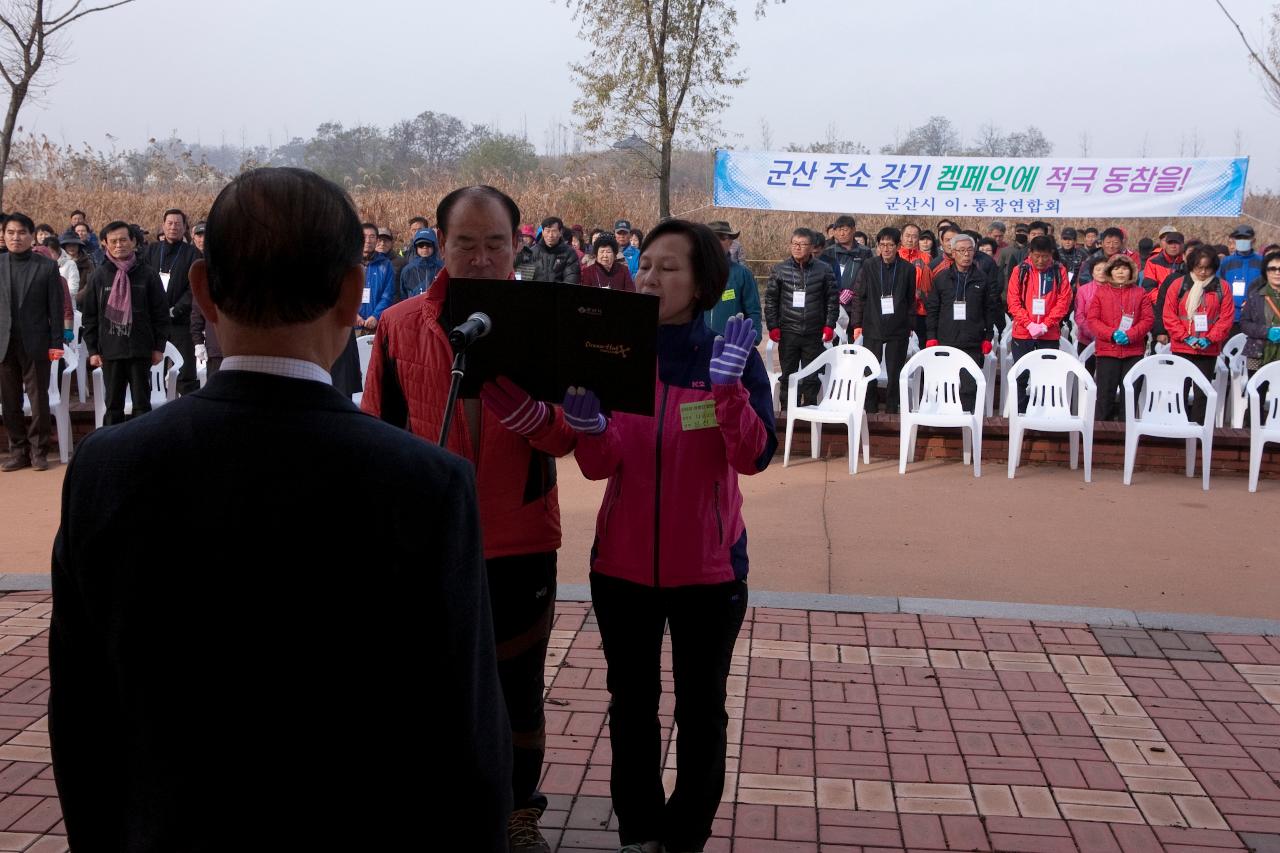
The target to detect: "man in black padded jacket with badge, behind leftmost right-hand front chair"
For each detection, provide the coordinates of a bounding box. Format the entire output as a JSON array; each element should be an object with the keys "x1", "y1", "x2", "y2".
[{"x1": 764, "y1": 228, "x2": 839, "y2": 405}]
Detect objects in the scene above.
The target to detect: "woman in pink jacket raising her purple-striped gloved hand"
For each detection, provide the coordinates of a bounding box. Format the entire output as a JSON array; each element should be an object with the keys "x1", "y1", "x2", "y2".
[{"x1": 564, "y1": 219, "x2": 778, "y2": 853}]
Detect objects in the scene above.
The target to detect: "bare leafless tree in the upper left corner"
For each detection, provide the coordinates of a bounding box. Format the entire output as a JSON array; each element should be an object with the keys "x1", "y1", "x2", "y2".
[{"x1": 0, "y1": 0, "x2": 133, "y2": 206}]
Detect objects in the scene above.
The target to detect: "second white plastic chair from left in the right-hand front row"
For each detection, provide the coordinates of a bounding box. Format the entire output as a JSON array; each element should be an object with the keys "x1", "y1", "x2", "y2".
[{"x1": 897, "y1": 347, "x2": 987, "y2": 476}]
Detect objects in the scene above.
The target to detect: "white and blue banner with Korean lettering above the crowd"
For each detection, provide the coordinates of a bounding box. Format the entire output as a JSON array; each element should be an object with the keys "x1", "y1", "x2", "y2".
[{"x1": 714, "y1": 150, "x2": 1249, "y2": 219}]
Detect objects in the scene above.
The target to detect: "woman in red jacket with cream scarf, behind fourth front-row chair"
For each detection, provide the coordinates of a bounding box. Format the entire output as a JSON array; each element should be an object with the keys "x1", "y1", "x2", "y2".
[{"x1": 1164, "y1": 246, "x2": 1235, "y2": 424}]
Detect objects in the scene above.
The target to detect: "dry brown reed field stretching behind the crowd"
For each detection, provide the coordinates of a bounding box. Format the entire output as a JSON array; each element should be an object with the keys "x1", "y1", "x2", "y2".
[{"x1": 4, "y1": 166, "x2": 1280, "y2": 260}]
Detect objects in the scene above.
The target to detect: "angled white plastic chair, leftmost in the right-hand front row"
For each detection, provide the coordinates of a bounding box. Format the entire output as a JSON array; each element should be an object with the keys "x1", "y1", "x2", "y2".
[{"x1": 782, "y1": 345, "x2": 879, "y2": 474}]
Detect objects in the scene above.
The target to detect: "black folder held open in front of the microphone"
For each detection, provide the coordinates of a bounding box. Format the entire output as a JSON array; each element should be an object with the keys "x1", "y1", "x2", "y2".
[{"x1": 444, "y1": 278, "x2": 658, "y2": 416}]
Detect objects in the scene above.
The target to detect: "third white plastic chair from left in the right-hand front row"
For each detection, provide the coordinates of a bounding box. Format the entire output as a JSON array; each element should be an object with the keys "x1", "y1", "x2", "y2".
[{"x1": 1005, "y1": 345, "x2": 1098, "y2": 483}]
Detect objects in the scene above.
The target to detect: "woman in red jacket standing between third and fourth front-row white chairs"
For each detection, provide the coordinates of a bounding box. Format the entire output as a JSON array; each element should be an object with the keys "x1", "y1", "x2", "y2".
[{"x1": 1080, "y1": 255, "x2": 1156, "y2": 420}]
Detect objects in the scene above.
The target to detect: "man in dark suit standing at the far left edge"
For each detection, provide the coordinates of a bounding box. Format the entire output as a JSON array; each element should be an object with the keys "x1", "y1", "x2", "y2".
[{"x1": 0, "y1": 213, "x2": 64, "y2": 471}]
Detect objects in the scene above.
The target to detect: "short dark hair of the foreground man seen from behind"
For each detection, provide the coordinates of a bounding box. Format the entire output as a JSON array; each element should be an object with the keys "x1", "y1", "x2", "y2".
[{"x1": 205, "y1": 168, "x2": 364, "y2": 328}]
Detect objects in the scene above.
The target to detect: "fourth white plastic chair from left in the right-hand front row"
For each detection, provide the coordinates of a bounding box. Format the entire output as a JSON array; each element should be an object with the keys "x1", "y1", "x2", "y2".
[{"x1": 1123, "y1": 355, "x2": 1217, "y2": 492}]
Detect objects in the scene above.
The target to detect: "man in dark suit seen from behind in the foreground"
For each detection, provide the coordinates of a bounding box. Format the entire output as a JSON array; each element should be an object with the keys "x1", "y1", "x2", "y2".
[{"x1": 49, "y1": 169, "x2": 511, "y2": 853}]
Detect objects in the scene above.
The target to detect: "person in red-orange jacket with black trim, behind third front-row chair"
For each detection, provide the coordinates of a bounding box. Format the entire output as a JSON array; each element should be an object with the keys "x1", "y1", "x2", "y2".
[{"x1": 1006, "y1": 234, "x2": 1074, "y2": 411}]
